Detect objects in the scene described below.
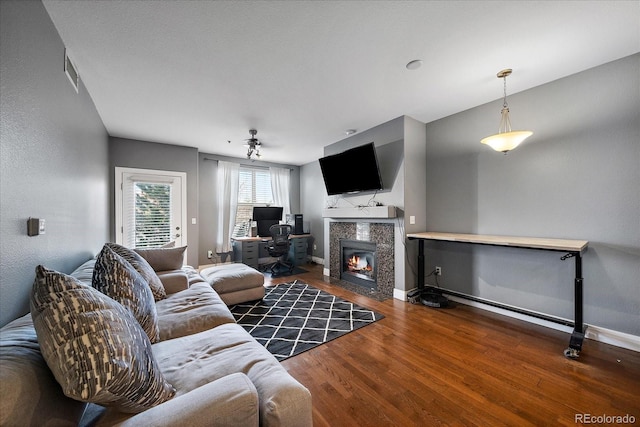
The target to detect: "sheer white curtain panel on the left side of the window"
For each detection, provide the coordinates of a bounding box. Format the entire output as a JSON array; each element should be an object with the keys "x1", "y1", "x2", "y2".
[{"x1": 216, "y1": 161, "x2": 240, "y2": 253}]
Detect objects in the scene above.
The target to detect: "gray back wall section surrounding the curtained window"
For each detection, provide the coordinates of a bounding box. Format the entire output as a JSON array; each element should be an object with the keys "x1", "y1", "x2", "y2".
[{"x1": 198, "y1": 153, "x2": 302, "y2": 265}]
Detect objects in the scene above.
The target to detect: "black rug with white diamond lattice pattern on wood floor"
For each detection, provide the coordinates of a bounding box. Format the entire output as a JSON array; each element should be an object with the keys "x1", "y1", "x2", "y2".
[{"x1": 230, "y1": 281, "x2": 384, "y2": 360}]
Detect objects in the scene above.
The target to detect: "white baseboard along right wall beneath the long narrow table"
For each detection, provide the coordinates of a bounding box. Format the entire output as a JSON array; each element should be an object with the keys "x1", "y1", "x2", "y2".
[{"x1": 448, "y1": 296, "x2": 640, "y2": 351}]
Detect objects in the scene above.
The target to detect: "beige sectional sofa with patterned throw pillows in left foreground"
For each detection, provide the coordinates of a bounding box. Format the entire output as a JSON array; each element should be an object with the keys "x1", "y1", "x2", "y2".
[{"x1": 0, "y1": 245, "x2": 312, "y2": 427}]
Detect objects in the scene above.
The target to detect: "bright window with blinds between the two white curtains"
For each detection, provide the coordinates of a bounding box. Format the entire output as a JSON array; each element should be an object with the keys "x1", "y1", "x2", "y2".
[{"x1": 233, "y1": 166, "x2": 273, "y2": 237}]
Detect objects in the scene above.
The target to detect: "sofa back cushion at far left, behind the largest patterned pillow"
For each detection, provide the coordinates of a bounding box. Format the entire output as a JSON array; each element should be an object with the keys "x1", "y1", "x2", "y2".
[{"x1": 0, "y1": 314, "x2": 86, "y2": 426}]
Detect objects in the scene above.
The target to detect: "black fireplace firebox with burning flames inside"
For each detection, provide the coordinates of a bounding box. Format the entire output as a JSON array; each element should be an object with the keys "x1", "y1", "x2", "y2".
[{"x1": 340, "y1": 239, "x2": 377, "y2": 289}]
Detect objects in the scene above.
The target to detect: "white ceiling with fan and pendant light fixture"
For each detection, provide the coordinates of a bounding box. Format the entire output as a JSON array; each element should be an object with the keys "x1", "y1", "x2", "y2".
[{"x1": 44, "y1": 0, "x2": 640, "y2": 165}]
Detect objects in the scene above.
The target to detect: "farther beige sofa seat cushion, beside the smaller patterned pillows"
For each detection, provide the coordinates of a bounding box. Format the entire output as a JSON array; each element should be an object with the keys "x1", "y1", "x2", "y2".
[{"x1": 156, "y1": 282, "x2": 235, "y2": 341}]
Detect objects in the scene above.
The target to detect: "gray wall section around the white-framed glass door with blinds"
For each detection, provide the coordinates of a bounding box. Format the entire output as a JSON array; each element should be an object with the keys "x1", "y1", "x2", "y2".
[{"x1": 109, "y1": 138, "x2": 200, "y2": 266}]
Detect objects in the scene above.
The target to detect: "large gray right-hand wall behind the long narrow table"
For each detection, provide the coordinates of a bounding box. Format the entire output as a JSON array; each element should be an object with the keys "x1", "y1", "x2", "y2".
[{"x1": 426, "y1": 54, "x2": 640, "y2": 335}]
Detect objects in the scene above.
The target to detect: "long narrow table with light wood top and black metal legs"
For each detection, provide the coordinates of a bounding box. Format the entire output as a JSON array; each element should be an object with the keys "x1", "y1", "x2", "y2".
[{"x1": 407, "y1": 232, "x2": 589, "y2": 358}]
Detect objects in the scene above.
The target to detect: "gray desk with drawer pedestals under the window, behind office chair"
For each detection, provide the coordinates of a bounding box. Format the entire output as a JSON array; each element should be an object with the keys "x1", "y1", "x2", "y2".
[{"x1": 232, "y1": 234, "x2": 312, "y2": 270}]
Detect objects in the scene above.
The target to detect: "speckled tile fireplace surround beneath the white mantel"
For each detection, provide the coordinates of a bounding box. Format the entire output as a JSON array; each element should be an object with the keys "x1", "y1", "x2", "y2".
[{"x1": 329, "y1": 221, "x2": 395, "y2": 297}]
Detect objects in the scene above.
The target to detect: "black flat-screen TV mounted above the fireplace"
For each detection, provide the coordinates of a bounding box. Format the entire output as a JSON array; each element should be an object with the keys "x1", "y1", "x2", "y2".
[{"x1": 319, "y1": 142, "x2": 382, "y2": 196}]
